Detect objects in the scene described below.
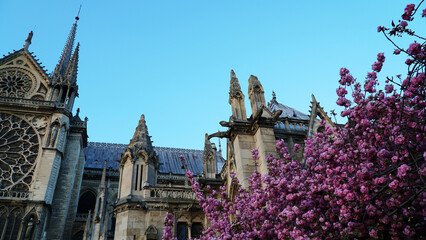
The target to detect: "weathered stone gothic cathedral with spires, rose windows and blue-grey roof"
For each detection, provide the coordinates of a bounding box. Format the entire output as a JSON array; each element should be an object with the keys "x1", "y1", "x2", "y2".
[{"x1": 0, "y1": 17, "x2": 333, "y2": 240}]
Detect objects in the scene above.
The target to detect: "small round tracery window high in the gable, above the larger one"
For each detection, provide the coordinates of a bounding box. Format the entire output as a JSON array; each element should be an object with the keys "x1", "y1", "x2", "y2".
[{"x1": 0, "y1": 70, "x2": 33, "y2": 98}]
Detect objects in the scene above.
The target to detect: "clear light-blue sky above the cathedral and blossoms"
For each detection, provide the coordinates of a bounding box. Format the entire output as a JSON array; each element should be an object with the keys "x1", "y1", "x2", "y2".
[{"x1": 0, "y1": 0, "x2": 426, "y2": 149}]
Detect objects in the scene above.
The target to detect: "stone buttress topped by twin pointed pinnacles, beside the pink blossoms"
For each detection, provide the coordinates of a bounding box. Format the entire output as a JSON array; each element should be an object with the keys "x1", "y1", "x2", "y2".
[{"x1": 221, "y1": 71, "x2": 275, "y2": 189}]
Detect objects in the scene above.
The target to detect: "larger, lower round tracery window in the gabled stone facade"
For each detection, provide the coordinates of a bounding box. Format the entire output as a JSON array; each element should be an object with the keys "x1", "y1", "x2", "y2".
[{"x1": 0, "y1": 113, "x2": 39, "y2": 191}]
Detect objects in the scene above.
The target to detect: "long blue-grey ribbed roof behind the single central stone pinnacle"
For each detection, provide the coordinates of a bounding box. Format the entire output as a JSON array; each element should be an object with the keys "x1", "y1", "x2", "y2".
[{"x1": 84, "y1": 142, "x2": 225, "y2": 175}]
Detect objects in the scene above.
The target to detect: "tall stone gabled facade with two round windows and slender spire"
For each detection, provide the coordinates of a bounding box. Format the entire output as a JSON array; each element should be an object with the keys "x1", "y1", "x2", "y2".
[{"x1": 0, "y1": 15, "x2": 87, "y2": 239}]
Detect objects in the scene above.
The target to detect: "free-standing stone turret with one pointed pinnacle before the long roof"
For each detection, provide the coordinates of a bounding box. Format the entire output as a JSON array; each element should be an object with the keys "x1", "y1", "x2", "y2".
[{"x1": 115, "y1": 115, "x2": 159, "y2": 239}]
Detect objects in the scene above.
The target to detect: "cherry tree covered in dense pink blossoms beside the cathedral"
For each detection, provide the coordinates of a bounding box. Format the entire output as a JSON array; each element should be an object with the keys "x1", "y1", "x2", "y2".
[{"x1": 163, "y1": 1, "x2": 426, "y2": 239}]
